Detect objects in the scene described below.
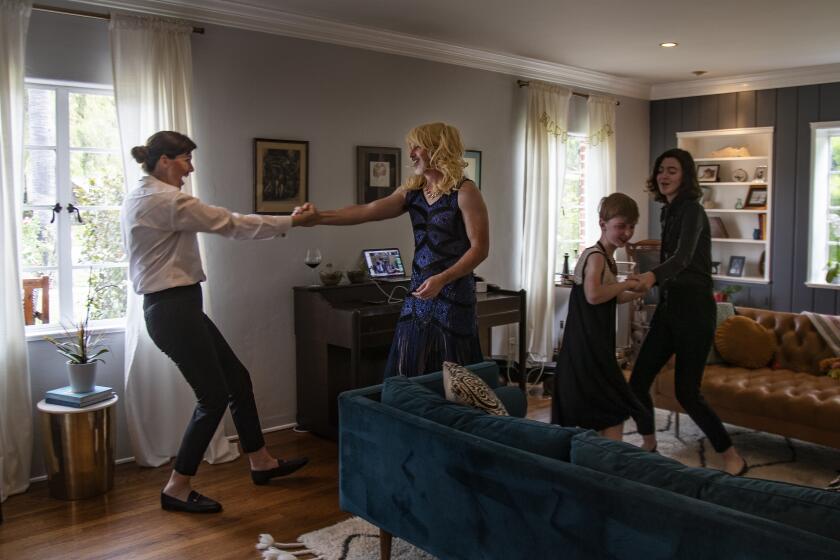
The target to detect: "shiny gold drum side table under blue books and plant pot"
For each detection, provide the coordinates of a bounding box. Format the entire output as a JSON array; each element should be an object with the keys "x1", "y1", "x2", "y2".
[{"x1": 38, "y1": 395, "x2": 119, "y2": 500}]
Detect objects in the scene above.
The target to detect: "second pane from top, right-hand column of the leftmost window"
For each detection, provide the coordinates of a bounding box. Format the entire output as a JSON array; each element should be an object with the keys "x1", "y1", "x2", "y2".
[{"x1": 70, "y1": 152, "x2": 124, "y2": 206}]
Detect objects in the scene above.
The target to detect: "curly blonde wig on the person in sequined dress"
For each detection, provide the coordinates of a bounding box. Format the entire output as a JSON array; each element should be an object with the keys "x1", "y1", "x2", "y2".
[{"x1": 403, "y1": 122, "x2": 467, "y2": 194}]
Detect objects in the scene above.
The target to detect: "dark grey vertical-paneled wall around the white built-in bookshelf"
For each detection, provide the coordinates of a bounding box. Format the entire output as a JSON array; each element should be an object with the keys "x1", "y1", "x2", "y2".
[{"x1": 649, "y1": 83, "x2": 840, "y2": 314}]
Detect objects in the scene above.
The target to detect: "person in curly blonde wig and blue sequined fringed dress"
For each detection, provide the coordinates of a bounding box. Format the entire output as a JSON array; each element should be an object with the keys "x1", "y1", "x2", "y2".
[{"x1": 304, "y1": 123, "x2": 490, "y2": 377}]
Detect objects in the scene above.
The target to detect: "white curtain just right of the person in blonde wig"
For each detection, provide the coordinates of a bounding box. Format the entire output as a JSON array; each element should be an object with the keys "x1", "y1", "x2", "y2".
[{"x1": 522, "y1": 80, "x2": 572, "y2": 361}]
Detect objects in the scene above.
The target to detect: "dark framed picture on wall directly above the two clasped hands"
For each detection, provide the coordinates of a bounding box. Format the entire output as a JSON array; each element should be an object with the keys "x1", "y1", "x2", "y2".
[{"x1": 254, "y1": 138, "x2": 309, "y2": 214}]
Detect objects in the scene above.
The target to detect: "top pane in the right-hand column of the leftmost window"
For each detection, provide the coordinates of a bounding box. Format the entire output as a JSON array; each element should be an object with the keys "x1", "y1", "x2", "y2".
[{"x1": 68, "y1": 93, "x2": 120, "y2": 149}]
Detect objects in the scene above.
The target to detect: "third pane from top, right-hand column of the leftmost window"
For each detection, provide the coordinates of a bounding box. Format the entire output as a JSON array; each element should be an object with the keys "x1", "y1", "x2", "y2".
[{"x1": 71, "y1": 210, "x2": 125, "y2": 265}]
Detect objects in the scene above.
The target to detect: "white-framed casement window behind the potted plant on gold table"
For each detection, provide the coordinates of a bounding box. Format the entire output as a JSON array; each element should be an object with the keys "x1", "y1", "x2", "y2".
[{"x1": 19, "y1": 82, "x2": 127, "y2": 329}]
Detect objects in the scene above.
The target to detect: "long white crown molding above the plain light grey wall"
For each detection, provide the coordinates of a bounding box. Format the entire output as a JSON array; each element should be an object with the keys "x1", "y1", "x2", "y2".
[{"x1": 69, "y1": 0, "x2": 650, "y2": 99}]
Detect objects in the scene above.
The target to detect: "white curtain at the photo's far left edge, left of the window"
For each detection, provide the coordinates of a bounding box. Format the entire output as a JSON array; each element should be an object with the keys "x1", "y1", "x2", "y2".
[{"x1": 0, "y1": 0, "x2": 32, "y2": 501}]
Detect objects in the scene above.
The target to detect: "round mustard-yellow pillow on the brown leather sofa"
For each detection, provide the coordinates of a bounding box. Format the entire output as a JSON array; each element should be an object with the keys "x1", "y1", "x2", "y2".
[{"x1": 715, "y1": 315, "x2": 776, "y2": 369}]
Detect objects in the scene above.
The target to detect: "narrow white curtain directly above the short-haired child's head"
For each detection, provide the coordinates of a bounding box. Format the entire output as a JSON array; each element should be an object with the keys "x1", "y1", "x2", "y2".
[{"x1": 585, "y1": 95, "x2": 615, "y2": 246}]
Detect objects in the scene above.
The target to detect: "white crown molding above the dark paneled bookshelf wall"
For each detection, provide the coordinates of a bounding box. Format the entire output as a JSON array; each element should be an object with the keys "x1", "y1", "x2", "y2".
[{"x1": 650, "y1": 64, "x2": 840, "y2": 100}]
